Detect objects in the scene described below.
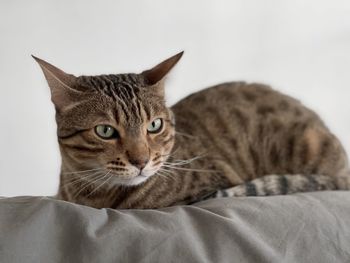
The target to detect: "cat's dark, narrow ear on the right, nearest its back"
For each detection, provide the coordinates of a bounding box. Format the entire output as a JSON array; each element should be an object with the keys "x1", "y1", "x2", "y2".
[{"x1": 141, "y1": 51, "x2": 184, "y2": 86}]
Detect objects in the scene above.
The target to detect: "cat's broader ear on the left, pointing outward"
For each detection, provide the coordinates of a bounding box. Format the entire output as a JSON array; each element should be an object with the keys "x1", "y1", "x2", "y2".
[{"x1": 32, "y1": 55, "x2": 81, "y2": 111}]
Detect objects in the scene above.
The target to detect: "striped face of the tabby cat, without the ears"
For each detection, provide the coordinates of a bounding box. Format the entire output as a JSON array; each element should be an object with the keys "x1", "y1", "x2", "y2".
[{"x1": 57, "y1": 75, "x2": 175, "y2": 185}]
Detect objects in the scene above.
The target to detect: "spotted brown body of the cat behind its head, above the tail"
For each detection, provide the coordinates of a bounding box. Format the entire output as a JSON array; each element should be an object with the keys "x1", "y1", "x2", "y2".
[{"x1": 172, "y1": 82, "x2": 345, "y2": 184}]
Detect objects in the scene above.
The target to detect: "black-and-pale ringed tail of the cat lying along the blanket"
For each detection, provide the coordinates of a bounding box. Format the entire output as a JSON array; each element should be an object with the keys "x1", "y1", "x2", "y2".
[{"x1": 211, "y1": 171, "x2": 350, "y2": 198}]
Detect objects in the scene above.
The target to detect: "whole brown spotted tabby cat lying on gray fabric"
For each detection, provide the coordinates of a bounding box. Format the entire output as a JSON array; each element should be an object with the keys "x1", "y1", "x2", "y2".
[{"x1": 33, "y1": 52, "x2": 350, "y2": 209}]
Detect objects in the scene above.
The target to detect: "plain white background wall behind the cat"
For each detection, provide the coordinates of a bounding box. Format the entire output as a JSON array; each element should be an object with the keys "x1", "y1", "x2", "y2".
[{"x1": 0, "y1": 0, "x2": 350, "y2": 196}]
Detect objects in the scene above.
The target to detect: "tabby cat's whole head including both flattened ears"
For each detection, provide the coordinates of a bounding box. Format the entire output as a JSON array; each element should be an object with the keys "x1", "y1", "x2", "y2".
[{"x1": 34, "y1": 52, "x2": 183, "y2": 185}]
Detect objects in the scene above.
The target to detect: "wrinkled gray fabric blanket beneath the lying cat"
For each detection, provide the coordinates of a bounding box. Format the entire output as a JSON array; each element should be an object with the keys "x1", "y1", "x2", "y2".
[{"x1": 0, "y1": 191, "x2": 350, "y2": 263}]
